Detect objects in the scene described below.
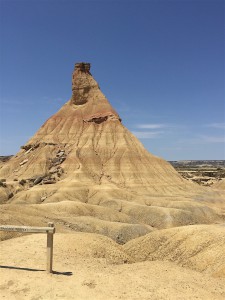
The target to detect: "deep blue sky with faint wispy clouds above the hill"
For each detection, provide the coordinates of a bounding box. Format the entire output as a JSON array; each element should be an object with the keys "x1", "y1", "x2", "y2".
[{"x1": 0, "y1": 0, "x2": 225, "y2": 160}]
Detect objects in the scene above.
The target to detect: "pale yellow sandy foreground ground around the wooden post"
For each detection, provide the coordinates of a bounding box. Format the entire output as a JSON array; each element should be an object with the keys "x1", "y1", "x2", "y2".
[{"x1": 0, "y1": 233, "x2": 225, "y2": 300}]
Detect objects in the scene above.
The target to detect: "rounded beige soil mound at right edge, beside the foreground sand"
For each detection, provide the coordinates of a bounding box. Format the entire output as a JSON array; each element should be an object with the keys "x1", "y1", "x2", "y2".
[{"x1": 123, "y1": 224, "x2": 225, "y2": 278}]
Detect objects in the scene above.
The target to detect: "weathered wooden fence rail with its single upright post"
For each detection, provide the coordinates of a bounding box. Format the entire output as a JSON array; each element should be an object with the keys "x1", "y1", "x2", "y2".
[{"x1": 0, "y1": 222, "x2": 55, "y2": 273}]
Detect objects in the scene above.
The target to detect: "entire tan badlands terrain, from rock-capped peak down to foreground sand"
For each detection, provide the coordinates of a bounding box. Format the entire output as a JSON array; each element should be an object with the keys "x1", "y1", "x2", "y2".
[{"x1": 0, "y1": 63, "x2": 225, "y2": 300}]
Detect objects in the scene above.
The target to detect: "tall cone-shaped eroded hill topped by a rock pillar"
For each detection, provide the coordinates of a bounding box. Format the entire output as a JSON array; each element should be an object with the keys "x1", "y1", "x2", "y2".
[{"x1": 0, "y1": 62, "x2": 222, "y2": 236}]
